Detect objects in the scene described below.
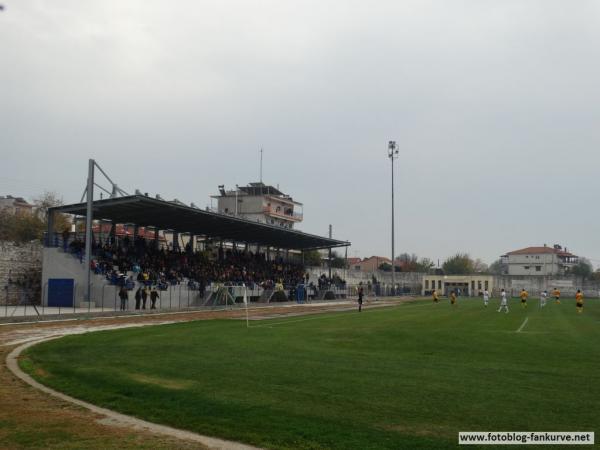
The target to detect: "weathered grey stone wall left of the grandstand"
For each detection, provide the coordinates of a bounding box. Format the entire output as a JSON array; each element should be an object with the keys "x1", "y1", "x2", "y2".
[{"x1": 0, "y1": 241, "x2": 42, "y2": 305}]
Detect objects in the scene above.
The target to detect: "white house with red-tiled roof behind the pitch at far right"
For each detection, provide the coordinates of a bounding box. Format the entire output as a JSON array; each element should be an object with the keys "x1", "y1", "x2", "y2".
[{"x1": 500, "y1": 244, "x2": 578, "y2": 276}]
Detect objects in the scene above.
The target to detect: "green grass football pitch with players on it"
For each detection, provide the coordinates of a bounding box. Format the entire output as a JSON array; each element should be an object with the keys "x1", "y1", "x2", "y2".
[{"x1": 21, "y1": 299, "x2": 600, "y2": 449}]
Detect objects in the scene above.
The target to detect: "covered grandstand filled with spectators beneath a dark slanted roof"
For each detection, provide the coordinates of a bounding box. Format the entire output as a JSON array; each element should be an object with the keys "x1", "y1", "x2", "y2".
[{"x1": 42, "y1": 194, "x2": 350, "y2": 309}]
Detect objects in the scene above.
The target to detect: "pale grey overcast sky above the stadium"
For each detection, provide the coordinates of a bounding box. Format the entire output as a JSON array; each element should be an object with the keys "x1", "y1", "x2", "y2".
[{"x1": 0, "y1": 0, "x2": 600, "y2": 266}]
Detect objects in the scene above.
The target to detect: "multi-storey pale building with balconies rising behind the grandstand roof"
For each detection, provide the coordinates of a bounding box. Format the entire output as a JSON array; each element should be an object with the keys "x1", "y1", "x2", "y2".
[{"x1": 212, "y1": 183, "x2": 302, "y2": 228}]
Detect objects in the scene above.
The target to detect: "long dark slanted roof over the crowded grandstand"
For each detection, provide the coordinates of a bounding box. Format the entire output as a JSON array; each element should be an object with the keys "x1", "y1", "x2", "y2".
[{"x1": 50, "y1": 195, "x2": 350, "y2": 250}]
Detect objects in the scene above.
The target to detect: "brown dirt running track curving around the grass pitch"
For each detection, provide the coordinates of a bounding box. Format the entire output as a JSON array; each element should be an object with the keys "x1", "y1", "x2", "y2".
[{"x1": 0, "y1": 301, "x2": 404, "y2": 450}]
